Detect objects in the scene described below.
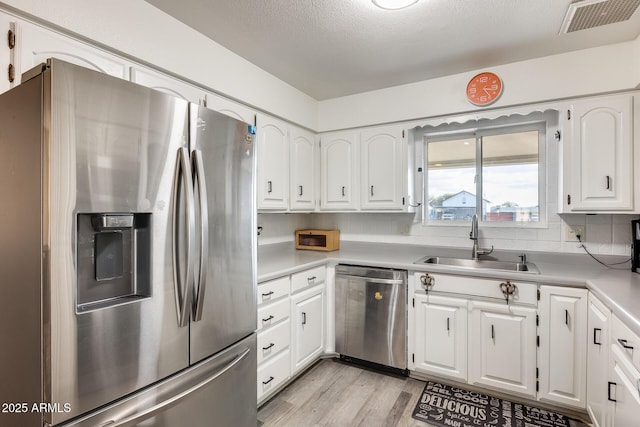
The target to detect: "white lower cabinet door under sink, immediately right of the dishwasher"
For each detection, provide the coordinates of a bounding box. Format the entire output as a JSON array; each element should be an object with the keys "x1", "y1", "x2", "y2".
[{"x1": 411, "y1": 295, "x2": 467, "y2": 381}]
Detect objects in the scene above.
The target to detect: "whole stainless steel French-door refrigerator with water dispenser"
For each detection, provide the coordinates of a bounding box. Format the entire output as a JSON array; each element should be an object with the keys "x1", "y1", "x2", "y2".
[{"x1": 0, "y1": 59, "x2": 257, "y2": 427}]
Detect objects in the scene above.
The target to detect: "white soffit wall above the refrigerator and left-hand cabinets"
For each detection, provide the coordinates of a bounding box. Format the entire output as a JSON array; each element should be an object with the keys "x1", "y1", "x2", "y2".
[{"x1": 0, "y1": 0, "x2": 317, "y2": 129}]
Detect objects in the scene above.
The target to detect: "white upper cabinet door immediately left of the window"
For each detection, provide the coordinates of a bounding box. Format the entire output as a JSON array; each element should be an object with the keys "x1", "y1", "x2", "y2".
[{"x1": 360, "y1": 126, "x2": 406, "y2": 210}]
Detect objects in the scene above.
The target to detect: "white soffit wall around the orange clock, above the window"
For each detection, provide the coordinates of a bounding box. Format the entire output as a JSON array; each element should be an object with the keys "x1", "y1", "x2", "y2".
[{"x1": 318, "y1": 38, "x2": 640, "y2": 131}]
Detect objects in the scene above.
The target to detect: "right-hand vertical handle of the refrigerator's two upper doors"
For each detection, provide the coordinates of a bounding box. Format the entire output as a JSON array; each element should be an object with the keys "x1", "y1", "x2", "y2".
[{"x1": 191, "y1": 150, "x2": 209, "y2": 322}]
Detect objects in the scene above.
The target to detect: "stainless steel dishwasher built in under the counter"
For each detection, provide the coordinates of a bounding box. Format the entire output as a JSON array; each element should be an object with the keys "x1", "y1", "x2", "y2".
[{"x1": 336, "y1": 265, "x2": 407, "y2": 374}]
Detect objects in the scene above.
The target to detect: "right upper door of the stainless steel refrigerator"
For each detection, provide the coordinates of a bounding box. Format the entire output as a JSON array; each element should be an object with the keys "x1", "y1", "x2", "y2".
[{"x1": 190, "y1": 104, "x2": 257, "y2": 363}]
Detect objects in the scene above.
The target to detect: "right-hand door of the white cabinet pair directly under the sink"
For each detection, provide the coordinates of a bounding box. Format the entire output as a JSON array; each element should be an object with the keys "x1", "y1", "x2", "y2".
[{"x1": 469, "y1": 301, "x2": 536, "y2": 397}]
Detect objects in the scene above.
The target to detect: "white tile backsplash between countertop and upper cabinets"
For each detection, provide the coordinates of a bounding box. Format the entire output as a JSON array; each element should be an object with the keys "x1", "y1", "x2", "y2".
[{"x1": 258, "y1": 213, "x2": 638, "y2": 255}]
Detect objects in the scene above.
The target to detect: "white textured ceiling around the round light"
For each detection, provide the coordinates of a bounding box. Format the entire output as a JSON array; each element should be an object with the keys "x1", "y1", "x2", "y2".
[{"x1": 146, "y1": 0, "x2": 640, "y2": 100}]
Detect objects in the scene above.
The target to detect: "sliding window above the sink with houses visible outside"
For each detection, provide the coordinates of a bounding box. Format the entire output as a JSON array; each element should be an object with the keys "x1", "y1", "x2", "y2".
[{"x1": 423, "y1": 113, "x2": 547, "y2": 226}]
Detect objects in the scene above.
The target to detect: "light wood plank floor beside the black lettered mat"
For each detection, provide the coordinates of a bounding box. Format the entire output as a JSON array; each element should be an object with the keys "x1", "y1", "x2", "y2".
[{"x1": 258, "y1": 359, "x2": 428, "y2": 427}]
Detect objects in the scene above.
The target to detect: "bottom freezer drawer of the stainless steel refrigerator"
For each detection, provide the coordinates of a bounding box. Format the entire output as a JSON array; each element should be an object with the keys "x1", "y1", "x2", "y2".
[{"x1": 60, "y1": 334, "x2": 257, "y2": 427}]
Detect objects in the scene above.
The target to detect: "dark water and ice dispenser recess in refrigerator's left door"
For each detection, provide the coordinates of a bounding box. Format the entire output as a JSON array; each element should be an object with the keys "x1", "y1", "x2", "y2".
[{"x1": 76, "y1": 213, "x2": 151, "y2": 313}]
